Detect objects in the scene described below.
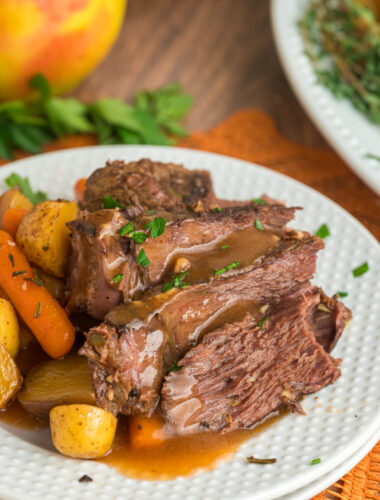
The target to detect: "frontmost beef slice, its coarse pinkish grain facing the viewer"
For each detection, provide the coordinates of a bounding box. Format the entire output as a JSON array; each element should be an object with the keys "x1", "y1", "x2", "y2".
[{"x1": 161, "y1": 283, "x2": 340, "y2": 434}]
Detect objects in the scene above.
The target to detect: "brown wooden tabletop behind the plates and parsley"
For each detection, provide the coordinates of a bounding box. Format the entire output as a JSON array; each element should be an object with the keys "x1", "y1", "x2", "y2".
[{"x1": 73, "y1": 0, "x2": 380, "y2": 238}]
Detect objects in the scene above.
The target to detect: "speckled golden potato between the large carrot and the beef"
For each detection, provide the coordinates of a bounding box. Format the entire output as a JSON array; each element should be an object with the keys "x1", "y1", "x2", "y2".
[{"x1": 16, "y1": 201, "x2": 78, "y2": 278}]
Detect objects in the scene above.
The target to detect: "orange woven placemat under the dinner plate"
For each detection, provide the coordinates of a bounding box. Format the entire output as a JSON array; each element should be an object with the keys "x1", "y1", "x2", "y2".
[{"x1": 0, "y1": 110, "x2": 380, "y2": 500}]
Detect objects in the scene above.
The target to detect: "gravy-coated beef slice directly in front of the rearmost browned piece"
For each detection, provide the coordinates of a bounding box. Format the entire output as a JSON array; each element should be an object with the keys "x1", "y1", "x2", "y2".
[{"x1": 66, "y1": 204, "x2": 295, "y2": 319}]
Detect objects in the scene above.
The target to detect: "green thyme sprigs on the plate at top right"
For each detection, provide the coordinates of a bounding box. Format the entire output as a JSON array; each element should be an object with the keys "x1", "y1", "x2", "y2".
[{"x1": 299, "y1": 0, "x2": 380, "y2": 124}]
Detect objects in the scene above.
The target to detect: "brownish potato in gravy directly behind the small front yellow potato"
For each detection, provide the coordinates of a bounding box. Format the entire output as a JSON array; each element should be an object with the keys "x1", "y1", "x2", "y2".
[{"x1": 17, "y1": 354, "x2": 95, "y2": 420}]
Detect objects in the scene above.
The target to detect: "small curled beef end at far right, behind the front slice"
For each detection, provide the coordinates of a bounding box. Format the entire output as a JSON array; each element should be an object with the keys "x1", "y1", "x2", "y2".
[{"x1": 311, "y1": 290, "x2": 352, "y2": 352}]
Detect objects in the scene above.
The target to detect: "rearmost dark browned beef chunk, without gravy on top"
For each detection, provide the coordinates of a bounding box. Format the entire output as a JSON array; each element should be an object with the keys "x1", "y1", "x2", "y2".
[{"x1": 81, "y1": 159, "x2": 216, "y2": 213}]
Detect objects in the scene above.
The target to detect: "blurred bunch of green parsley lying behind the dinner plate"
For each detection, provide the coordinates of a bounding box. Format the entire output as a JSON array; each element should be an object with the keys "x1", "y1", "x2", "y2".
[{"x1": 0, "y1": 74, "x2": 193, "y2": 159}]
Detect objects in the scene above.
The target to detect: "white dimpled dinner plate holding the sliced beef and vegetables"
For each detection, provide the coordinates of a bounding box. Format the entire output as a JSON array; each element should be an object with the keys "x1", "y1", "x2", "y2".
[{"x1": 0, "y1": 146, "x2": 380, "y2": 500}]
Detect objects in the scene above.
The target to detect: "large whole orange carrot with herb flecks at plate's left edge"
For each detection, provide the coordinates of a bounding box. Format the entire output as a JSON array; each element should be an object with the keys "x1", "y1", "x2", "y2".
[{"x1": 0, "y1": 231, "x2": 75, "y2": 358}]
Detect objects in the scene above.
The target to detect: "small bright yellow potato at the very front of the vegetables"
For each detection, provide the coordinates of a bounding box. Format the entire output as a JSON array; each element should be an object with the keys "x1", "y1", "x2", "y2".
[{"x1": 50, "y1": 404, "x2": 117, "y2": 458}]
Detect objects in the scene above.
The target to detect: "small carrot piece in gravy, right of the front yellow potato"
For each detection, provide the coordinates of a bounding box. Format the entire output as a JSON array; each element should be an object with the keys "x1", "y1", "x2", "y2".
[{"x1": 129, "y1": 415, "x2": 166, "y2": 448}]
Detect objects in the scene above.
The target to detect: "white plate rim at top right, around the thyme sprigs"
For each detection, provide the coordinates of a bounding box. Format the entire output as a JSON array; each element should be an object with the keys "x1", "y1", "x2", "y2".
[{"x1": 271, "y1": 0, "x2": 380, "y2": 194}]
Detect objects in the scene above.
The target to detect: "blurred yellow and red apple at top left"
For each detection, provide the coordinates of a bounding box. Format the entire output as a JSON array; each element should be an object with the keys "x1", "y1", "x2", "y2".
[{"x1": 0, "y1": 0, "x2": 127, "y2": 100}]
